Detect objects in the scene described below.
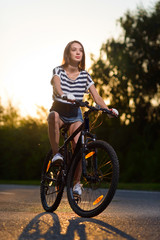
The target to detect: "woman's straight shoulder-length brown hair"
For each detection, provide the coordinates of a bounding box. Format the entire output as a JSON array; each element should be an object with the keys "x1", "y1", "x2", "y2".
[{"x1": 62, "y1": 40, "x2": 85, "y2": 70}]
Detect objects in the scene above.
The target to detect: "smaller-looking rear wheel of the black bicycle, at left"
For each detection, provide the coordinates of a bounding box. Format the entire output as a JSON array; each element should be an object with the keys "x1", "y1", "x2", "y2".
[{"x1": 40, "y1": 150, "x2": 64, "y2": 212}]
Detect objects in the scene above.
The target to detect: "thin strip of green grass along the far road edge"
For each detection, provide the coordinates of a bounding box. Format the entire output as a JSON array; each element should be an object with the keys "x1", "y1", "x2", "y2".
[{"x1": 0, "y1": 180, "x2": 160, "y2": 191}]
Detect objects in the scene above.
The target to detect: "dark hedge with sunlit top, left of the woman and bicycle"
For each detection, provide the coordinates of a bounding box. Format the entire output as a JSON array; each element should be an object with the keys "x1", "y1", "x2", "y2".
[{"x1": 0, "y1": 102, "x2": 50, "y2": 180}]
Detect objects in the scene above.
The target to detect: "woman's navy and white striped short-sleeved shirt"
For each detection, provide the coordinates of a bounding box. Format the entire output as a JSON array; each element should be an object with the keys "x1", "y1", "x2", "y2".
[{"x1": 51, "y1": 66, "x2": 94, "y2": 103}]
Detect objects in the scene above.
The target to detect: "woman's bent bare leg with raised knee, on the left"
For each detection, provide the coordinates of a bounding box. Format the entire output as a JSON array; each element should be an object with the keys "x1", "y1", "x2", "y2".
[{"x1": 48, "y1": 112, "x2": 64, "y2": 155}]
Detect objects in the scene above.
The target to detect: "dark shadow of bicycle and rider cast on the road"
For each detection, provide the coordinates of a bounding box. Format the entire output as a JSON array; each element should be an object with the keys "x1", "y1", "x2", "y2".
[{"x1": 19, "y1": 213, "x2": 136, "y2": 240}]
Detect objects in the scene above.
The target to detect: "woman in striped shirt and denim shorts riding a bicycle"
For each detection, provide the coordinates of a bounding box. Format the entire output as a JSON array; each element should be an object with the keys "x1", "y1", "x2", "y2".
[{"x1": 48, "y1": 41, "x2": 117, "y2": 195}]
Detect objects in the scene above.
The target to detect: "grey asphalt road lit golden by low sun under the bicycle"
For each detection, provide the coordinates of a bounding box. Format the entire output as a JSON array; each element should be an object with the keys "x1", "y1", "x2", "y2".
[{"x1": 0, "y1": 185, "x2": 160, "y2": 240}]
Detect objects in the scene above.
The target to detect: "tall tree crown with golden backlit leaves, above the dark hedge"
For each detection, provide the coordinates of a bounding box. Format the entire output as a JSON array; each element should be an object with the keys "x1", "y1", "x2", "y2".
[{"x1": 91, "y1": 1, "x2": 160, "y2": 126}]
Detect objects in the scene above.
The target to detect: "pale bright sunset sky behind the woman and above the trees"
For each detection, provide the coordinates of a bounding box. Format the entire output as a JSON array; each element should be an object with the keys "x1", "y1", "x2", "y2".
[{"x1": 0, "y1": 0, "x2": 157, "y2": 116}]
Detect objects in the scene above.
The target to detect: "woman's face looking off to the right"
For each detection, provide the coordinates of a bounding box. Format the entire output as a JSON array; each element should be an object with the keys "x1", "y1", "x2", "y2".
[{"x1": 70, "y1": 42, "x2": 83, "y2": 63}]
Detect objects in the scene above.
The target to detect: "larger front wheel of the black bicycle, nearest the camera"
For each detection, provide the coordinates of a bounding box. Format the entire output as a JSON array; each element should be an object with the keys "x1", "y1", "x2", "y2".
[{"x1": 67, "y1": 140, "x2": 119, "y2": 217}]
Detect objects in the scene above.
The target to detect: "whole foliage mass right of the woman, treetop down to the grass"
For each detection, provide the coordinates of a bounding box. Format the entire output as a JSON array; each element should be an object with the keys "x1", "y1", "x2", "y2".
[{"x1": 91, "y1": 1, "x2": 160, "y2": 182}]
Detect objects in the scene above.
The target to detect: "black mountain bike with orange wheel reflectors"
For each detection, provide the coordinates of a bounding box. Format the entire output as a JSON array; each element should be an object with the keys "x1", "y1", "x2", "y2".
[{"x1": 40, "y1": 101, "x2": 119, "y2": 217}]
